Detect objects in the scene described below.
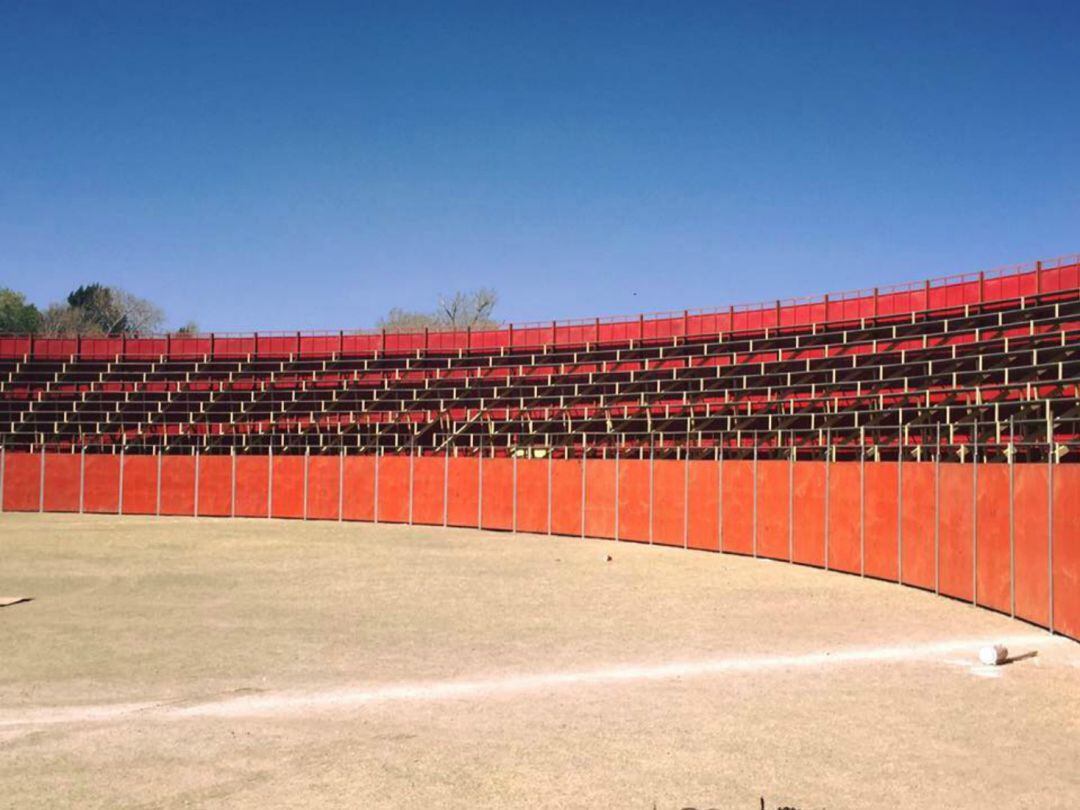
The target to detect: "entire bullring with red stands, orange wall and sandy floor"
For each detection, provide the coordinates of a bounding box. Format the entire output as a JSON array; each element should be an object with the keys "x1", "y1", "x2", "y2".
[{"x1": 0, "y1": 258, "x2": 1080, "y2": 808}]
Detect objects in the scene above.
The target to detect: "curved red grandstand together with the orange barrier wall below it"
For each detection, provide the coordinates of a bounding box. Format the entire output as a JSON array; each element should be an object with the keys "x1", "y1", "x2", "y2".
[{"x1": 0, "y1": 257, "x2": 1080, "y2": 639}]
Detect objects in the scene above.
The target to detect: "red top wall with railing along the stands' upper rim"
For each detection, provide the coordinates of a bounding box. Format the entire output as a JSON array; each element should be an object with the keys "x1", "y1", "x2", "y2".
[{"x1": 0, "y1": 255, "x2": 1080, "y2": 360}]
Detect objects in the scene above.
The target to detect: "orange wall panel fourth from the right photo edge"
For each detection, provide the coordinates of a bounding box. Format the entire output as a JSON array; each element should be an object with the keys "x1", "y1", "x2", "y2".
[{"x1": 937, "y1": 463, "x2": 974, "y2": 600}]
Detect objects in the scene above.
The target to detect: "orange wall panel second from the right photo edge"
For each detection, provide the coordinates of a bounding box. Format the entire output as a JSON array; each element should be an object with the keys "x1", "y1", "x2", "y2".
[{"x1": 1013, "y1": 463, "x2": 1050, "y2": 627}]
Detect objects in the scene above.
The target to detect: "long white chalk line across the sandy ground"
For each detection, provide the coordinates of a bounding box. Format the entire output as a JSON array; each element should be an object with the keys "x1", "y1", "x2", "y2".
[{"x1": 0, "y1": 633, "x2": 1071, "y2": 729}]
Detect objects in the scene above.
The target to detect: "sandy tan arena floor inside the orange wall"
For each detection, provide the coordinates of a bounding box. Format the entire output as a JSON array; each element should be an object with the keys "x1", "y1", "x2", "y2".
[{"x1": 0, "y1": 514, "x2": 1080, "y2": 810}]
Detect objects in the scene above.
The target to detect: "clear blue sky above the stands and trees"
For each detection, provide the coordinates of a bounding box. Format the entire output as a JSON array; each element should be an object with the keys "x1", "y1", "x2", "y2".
[{"x1": 0, "y1": 0, "x2": 1080, "y2": 330}]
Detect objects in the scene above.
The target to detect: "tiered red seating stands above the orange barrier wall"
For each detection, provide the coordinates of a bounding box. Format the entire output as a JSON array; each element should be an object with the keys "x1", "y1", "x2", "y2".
[{"x1": 0, "y1": 257, "x2": 1080, "y2": 460}]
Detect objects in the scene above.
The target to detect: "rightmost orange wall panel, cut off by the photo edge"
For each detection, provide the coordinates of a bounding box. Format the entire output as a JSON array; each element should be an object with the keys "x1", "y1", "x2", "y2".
[{"x1": 1053, "y1": 464, "x2": 1080, "y2": 640}]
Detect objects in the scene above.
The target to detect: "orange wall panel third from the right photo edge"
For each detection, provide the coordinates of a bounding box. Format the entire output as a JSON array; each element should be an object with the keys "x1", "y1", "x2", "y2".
[{"x1": 975, "y1": 464, "x2": 1011, "y2": 613}]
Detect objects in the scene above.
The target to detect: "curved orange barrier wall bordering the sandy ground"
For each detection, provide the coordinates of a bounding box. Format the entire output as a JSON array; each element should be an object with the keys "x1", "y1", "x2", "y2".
[{"x1": 0, "y1": 453, "x2": 1080, "y2": 638}]
